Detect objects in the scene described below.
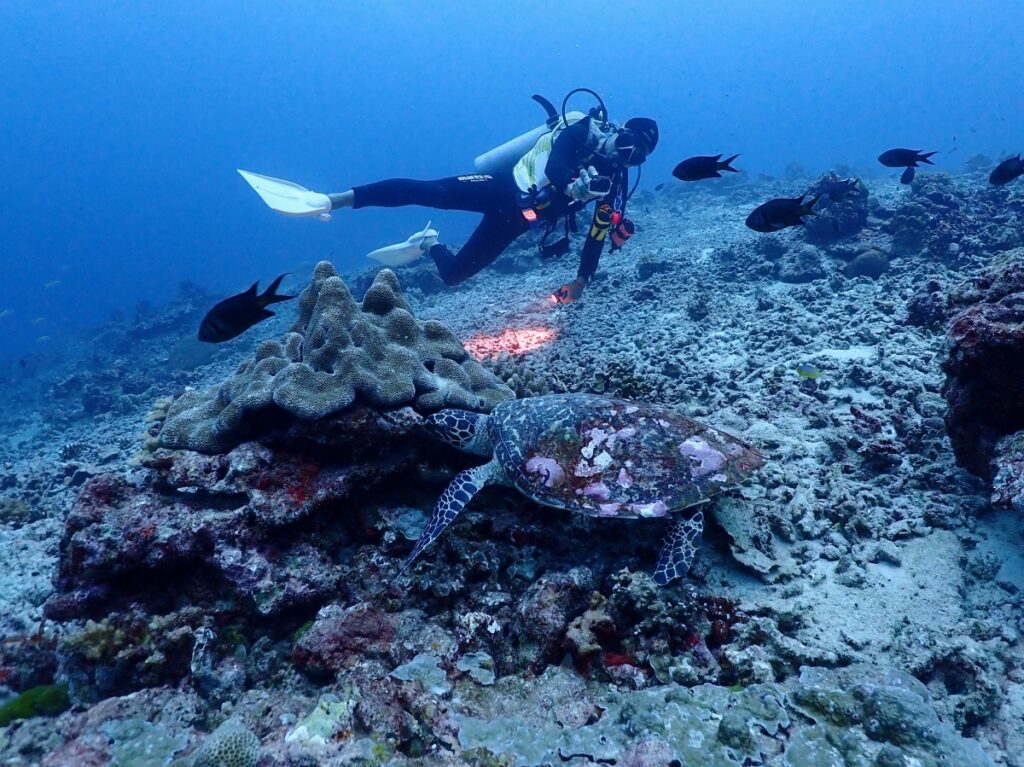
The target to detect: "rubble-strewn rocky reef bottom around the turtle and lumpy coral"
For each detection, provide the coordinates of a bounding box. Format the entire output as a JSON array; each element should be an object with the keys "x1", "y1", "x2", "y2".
[{"x1": 0, "y1": 173, "x2": 1024, "y2": 767}]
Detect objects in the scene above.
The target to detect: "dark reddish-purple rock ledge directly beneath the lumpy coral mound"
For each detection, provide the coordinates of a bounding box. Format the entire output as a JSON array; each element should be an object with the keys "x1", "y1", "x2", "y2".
[{"x1": 46, "y1": 408, "x2": 436, "y2": 621}]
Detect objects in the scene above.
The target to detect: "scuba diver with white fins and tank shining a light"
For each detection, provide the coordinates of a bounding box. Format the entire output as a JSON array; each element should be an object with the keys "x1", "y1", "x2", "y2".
[{"x1": 239, "y1": 88, "x2": 658, "y2": 303}]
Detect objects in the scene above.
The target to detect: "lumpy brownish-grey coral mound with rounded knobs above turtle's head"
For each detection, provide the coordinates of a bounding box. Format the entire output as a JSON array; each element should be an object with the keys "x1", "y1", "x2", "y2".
[{"x1": 160, "y1": 261, "x2": 513, "y2": 453}]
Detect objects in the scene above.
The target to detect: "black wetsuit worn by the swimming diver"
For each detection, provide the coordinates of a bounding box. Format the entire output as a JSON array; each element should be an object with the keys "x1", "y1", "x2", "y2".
[{"x1": 352, "y1": 118, "x2": 629, "y2": 285}]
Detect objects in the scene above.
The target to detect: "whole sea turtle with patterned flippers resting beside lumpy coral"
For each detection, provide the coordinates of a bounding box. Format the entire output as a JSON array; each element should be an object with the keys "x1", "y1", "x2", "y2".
[{"x1": 401, "y1": 394, "x2": 764, "y2": 585}]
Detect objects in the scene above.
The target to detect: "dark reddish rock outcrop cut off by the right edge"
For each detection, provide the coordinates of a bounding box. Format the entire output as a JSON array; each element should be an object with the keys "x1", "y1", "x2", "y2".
[{"x1": 942, "y1": 257, "x2": 1024, "y2": 480}]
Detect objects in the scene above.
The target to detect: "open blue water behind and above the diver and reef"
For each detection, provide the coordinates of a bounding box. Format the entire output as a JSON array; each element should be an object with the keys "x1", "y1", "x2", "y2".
[{"x1": 0, "y1": 0, "x2": 1024, "y2": 360}]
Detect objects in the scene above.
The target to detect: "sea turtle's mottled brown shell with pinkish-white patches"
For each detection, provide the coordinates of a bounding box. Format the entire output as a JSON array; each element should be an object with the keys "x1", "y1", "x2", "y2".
[{"x1": 487, "y1": 394, "x2": 764, "y2": 518}]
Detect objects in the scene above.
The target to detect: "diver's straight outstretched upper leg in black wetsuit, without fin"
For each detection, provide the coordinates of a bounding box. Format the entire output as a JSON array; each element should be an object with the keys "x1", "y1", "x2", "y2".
[{"x1": 348, "y1": 173, "x2": 516, "y2": 213}]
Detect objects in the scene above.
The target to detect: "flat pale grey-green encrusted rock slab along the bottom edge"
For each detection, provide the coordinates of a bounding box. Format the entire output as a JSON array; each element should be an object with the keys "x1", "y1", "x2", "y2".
[{"x1": 452, "y1": 666, "x2": 992, "y2": 767}]
